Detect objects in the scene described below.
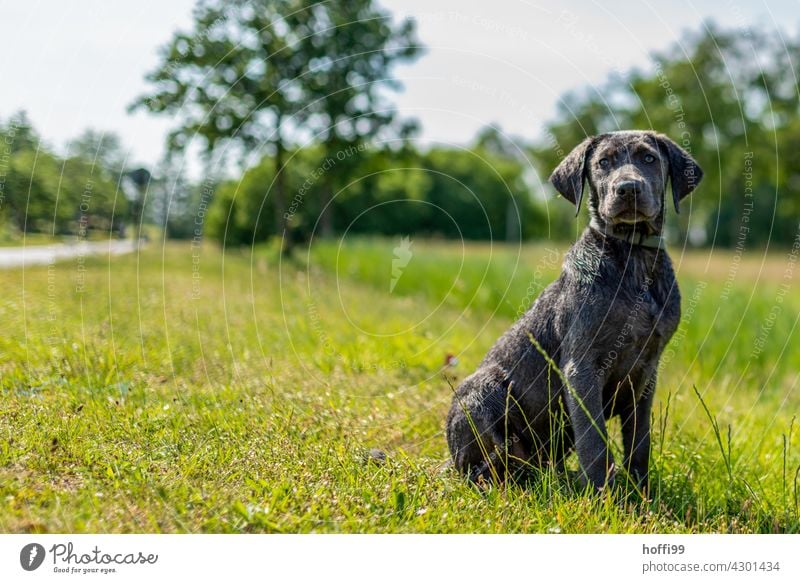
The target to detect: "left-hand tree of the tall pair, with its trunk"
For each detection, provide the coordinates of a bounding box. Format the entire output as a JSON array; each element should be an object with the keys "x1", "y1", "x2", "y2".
[{"x1": 133, "y1": 0, "x2": 306, "y2": 250}]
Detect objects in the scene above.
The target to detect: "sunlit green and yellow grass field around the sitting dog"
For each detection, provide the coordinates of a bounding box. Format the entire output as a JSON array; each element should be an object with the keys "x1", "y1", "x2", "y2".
[{"x1": 0, "y1": 240, "x2": 800, "y2": 533}]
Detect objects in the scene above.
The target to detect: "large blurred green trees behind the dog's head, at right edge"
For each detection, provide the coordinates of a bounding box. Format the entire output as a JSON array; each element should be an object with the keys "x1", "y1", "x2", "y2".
[{"x1": 532, "y1": 23, "x2": 800, "y2": 246}]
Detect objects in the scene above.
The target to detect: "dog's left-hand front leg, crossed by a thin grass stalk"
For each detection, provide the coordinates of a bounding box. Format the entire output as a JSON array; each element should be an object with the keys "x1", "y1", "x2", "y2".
[{"x1": 563, "y1": 361, "x2": 614, "y2": 490}]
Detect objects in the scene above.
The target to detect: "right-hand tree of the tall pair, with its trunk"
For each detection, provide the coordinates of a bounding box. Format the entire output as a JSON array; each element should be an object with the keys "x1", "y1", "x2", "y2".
[{"x1": 301, "y1": 0, "x2": 420, "y2": 236}]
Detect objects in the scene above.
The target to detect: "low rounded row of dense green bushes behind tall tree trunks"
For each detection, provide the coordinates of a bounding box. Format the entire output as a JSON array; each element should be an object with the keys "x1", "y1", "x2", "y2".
[{"x1": 207, "y1": 131, "x2": 548, "y2": 245}]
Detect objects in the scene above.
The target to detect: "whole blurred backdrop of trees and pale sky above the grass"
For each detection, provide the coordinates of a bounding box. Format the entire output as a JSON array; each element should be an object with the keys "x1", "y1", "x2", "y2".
[{"x1": 0, "y1": 0, "x2": 800, "y2": 251}]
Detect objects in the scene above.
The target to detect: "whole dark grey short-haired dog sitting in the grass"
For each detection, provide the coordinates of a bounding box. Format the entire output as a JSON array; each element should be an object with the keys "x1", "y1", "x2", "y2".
[{"x1": 447, "y1": 131, "x2": 702, "y2": 489}]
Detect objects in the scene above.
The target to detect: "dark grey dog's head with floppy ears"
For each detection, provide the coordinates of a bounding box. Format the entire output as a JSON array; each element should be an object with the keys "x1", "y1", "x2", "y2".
[{"x1": 550, "y1": 131, "x2": 703, "y2": 232}]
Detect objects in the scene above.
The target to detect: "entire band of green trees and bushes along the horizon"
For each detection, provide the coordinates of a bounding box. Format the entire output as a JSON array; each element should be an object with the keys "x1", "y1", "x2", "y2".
[{"x1": 0, "y1": 5, "x2": 800, "y2": 250}]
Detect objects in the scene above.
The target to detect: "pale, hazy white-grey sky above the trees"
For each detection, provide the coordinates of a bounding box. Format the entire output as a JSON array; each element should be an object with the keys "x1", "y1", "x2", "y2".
[{"x1": 0, "y1": 0, "x2": 800, "y2": 173}]
